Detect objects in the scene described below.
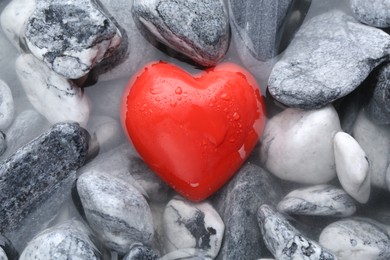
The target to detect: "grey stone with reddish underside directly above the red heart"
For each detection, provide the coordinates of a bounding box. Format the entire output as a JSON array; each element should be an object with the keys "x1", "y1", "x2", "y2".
[{"x1": 132, "y1": 0, "x2": 230, "y2": 66}]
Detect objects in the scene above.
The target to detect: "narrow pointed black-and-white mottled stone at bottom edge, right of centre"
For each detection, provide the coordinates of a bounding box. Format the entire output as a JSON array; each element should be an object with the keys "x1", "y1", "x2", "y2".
[{"x1": 257, "y1": 204, "x2": 337, "y2": 260}]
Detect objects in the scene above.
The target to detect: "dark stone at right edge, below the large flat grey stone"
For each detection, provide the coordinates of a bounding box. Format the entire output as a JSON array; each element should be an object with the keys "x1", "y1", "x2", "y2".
[{"x1": 367, "y1": 62, "x2": 390, "y2": 125}]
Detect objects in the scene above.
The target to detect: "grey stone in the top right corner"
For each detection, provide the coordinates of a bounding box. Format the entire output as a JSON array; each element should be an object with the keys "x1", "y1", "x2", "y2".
[{"x1": 350, "y1": 0, "x2": 390, "y2": 28}]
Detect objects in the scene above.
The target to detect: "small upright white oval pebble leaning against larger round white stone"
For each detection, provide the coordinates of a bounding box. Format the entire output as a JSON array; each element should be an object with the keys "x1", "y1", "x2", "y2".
[{"x1": 334, "y1": 132, "x2": 371, "y2": 203}]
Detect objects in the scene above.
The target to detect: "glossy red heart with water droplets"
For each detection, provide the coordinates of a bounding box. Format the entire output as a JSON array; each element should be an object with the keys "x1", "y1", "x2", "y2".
[{"x1": 121, "y1": 62, "x2": 265, "y2": 201}]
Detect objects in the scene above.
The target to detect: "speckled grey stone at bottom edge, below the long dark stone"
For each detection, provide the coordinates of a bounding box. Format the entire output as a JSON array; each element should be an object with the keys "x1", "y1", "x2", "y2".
[{"x1": 19, "y1": 220, "x2": 101, "y2": 260}]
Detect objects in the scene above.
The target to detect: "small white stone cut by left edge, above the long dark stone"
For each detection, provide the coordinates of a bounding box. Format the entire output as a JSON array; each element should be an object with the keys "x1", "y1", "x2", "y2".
[{"x1": 0, "y1": 80, "x2": 15, "y2": 130}]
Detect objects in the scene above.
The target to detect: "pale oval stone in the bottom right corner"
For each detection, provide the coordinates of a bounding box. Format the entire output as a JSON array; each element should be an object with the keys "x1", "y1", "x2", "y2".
[{"x1": 319, "y1": 218, "x2": 390, "y2": 260}]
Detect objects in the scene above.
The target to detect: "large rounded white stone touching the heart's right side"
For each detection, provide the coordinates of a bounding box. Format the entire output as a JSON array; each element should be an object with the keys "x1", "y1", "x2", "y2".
[{"x1": 260, "y1": 105, "x2": 341, "y2": 184}]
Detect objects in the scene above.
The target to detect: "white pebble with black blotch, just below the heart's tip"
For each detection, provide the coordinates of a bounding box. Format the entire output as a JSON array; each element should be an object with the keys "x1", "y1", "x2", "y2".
[{"x1": 163, "y1": 196, "x2": 225, "y2": 259}]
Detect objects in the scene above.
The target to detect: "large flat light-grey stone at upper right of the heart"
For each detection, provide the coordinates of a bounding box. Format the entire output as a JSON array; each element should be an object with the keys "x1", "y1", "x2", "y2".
[{"x1": 268, "y1": 10, "x2": 390, "y2": 109}]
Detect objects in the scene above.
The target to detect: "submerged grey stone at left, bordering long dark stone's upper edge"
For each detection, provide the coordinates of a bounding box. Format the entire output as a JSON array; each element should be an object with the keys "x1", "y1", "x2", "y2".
[{"x1": 0, "y1": 110, "x2": 50, "y2": 159}]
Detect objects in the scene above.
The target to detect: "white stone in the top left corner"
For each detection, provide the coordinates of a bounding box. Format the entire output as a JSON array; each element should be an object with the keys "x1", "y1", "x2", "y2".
[{"x1": 0, "y1": 0, "x2": 36, "y2": 51}]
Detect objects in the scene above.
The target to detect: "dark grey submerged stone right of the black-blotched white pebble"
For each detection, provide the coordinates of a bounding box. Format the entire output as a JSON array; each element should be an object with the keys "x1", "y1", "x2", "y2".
[{"x1": 212, "y1": 164, "x2": 281, "y2": 259}]
